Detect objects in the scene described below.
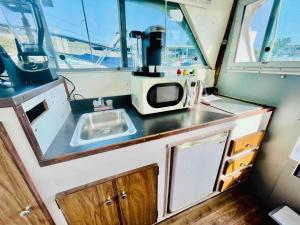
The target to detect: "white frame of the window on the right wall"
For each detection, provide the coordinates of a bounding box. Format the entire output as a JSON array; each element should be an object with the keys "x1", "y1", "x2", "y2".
[{"x1": 227, "y1": 0, "x2": 300, "y2": 75}]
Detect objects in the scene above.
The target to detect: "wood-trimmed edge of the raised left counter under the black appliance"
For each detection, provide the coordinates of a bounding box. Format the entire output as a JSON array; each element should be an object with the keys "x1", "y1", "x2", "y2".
[{"x1": 0, "y1": 78, "x2": 64, "y2": 108}]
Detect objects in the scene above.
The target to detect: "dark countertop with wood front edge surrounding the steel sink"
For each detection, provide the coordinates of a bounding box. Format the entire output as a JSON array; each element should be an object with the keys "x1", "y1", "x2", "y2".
[{"x1": 41, "y1": 101, "x2": 235, "y2": 165}]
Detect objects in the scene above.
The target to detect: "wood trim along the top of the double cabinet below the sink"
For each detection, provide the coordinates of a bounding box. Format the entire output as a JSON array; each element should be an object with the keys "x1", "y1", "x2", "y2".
[{"x1": 55, "y1": 163, "x2": 159, "y2": 199}]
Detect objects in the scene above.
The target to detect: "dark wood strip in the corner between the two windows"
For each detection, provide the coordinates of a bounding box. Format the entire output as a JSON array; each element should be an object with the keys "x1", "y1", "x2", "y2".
[{"x1": 214, "y1": 0, "x2": 238, "y2": 86}]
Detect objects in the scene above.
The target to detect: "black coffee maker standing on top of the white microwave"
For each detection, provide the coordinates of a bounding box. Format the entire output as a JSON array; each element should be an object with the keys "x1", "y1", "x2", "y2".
[{"x1": 129, "y1": 26, "x2": 166, "y2": 77}]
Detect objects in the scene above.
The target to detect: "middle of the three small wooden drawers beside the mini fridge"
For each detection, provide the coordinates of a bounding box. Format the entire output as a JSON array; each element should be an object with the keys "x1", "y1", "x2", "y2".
[{"x1": 223, "y1": 151, "x2": 257, "y2": 175}]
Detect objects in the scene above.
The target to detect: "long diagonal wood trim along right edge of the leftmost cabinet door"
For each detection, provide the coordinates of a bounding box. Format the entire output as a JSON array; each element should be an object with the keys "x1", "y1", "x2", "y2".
[{"x1": 0, "y1": 122, "x2": 55, "y2": 225}]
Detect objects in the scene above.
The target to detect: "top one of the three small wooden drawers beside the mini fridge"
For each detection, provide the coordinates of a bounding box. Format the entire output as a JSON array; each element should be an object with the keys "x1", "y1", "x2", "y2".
[{"x1": 228, "y1": 131, "x2": 265, "y2": 156}]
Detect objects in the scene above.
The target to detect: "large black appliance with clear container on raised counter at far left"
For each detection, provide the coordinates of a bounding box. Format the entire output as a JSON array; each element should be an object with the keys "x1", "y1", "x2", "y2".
[{"x1": 0, "y1": 0, "x2": 58, "y2": 88}]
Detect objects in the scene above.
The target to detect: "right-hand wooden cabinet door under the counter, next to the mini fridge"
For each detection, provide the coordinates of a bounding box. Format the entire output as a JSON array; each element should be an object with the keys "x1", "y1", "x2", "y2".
[{"x1": 115, "y1": 166, "x2": 158, "y2": 225}]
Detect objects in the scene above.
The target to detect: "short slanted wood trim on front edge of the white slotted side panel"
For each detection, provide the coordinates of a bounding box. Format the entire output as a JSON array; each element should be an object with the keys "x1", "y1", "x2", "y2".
[{"x1": 14, "y1": 105, "x2": 44, "y2": 163}]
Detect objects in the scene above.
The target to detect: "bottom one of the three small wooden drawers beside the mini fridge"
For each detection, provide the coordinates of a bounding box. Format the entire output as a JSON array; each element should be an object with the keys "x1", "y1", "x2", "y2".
[{"x1": 219, "y1": 168, "x2": 251, "y2": 192}]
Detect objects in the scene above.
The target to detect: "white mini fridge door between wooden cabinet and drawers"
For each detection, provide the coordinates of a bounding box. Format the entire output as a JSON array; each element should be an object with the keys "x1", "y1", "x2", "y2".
[{"x1": 169, "y1": 132, "x2": 228, "y2": 212}]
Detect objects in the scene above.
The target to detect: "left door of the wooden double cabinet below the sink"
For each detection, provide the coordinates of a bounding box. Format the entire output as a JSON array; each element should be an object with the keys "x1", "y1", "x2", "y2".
[{"x1": 56, "y1": 181, "x2": 120, "y2": 225}]
